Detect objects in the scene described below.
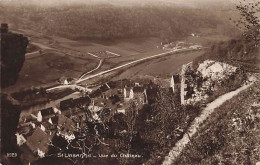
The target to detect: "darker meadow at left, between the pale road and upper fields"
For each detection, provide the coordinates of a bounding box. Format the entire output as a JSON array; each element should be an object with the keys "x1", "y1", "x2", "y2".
[{"x1": 3, "y1": 53, "x2": 98, "y2": 92}]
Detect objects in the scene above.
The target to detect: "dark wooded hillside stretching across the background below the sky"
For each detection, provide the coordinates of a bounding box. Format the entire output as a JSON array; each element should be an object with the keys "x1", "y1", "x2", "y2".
[{"x1": 0, "y1": 5, "x2": 236, "y2": 40}]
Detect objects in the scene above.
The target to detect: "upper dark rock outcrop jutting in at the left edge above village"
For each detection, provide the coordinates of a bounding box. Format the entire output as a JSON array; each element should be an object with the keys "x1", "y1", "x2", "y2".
[{"x1": 0, "y1": 27, "x2": 28, "y2": 88}]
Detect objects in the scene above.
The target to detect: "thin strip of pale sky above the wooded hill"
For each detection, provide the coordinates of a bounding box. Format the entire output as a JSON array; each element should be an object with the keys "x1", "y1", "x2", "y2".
[{"x1": 0, "y1": 0, "x2": 242, "y2": 7}]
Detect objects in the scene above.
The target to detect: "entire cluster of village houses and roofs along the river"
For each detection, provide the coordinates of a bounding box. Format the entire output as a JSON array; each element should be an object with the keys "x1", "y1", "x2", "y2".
[{"x1": 16, "y1": 80, "x2": 158, "y2": 157}]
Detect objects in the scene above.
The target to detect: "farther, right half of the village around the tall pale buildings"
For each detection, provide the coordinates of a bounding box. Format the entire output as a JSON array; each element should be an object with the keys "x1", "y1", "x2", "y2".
[{"x1": 89, "y1": 79, "x2": 158, "y2": 114}]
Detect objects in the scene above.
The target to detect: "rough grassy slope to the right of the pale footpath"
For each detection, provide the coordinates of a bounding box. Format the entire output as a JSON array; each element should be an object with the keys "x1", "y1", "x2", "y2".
[{"x1": 176, "y1": 80, "x2": 260, "y2": 165}]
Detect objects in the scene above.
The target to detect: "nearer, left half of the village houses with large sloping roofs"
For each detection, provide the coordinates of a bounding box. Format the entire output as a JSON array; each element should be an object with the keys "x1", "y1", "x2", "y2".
[{"x1": 16, "y1": 97, "x2": 90, "y2": 157}]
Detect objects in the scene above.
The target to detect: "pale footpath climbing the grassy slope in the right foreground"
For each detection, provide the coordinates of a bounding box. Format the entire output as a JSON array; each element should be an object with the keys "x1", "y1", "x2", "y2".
[{"x1": 162, "y1": 78, "x2": 254, "y2": 165}]
